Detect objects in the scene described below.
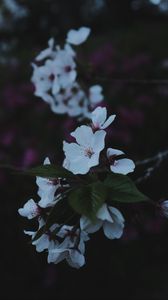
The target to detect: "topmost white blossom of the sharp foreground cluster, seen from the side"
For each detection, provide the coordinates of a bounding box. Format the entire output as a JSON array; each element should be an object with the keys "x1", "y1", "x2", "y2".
[{"x1": 91, "y1": 106, "x2": 116, "y2": 130}]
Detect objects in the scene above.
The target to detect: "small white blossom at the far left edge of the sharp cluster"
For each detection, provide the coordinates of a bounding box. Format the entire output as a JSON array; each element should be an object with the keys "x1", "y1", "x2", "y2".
[{"x1": 18, "y1": 199, "x2": 40, "y2": 219}]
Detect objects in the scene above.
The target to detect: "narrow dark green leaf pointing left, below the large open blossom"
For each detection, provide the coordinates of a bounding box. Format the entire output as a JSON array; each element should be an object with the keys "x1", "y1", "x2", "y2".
[{"x1": 24, "y1": 164, "x2": 75, "y2": 178}]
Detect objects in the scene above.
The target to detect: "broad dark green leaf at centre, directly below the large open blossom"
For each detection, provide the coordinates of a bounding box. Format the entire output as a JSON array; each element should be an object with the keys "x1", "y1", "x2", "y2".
[{"x1": 68, "y1": 181, "x2": 107, "y2": 221}]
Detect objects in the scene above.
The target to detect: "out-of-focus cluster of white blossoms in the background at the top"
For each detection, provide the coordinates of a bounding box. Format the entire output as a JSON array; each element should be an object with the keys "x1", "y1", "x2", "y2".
[{"x1": 32, "y1": 27, "x2": 103, "y2": 117}]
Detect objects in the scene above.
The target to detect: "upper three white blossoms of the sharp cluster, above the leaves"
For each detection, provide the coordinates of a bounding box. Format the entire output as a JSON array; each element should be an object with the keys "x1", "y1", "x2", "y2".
[{"x1": 63, "y1": 107, "x2": 135, "y2": 175}]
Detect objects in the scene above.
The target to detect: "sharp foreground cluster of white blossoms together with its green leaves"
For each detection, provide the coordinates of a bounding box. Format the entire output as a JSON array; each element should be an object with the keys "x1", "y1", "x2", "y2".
[{"x1": 18, "y1": 107, "x2": 138, "y2": 268}]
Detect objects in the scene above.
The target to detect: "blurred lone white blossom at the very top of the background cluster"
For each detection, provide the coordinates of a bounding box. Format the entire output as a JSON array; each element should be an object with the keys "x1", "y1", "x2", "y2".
[{"x1": 67, "y1": 27, "x2": 91, "y2": 46}]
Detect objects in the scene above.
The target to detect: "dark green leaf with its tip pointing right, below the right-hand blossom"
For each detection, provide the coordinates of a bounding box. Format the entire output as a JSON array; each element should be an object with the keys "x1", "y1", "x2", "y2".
[{"x1": 104, "y1": 174, "x2": 148, "y2": 203}]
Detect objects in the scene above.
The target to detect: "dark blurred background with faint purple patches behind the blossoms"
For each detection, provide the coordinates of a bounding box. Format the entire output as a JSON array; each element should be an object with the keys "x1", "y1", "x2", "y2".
[{"x1": 0, "y1": 0, "x2": 168, "y2": 300}]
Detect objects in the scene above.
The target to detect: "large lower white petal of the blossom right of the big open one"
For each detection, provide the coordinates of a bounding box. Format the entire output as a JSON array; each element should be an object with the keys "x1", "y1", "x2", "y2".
[{"x1": 110, "y1": 158, "x2": 135, "y2": 175}]
